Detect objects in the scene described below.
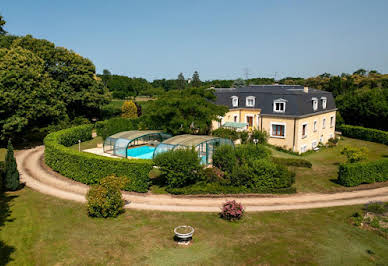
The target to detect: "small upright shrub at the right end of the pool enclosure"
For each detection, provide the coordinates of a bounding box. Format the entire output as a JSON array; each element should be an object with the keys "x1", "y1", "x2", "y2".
[{"x1": 213, "y1": 145, "x2": 238, "y2": 173}]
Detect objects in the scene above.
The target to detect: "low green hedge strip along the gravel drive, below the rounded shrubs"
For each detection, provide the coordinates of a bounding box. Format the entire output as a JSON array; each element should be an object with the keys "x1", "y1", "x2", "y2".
[{"x1": 166, "y1": 182, "x2": 296, "y2": 195}]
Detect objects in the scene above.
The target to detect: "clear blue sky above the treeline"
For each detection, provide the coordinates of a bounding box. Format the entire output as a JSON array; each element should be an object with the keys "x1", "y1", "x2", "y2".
[{"x1": 0, "y1": 0, "x2": 388, "y2": 80}]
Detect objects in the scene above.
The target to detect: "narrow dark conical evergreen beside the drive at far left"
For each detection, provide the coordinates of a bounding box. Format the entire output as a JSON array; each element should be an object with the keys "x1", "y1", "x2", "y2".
[{"x1": 4, "y1": 139, "x2": 20, "y2": 191}]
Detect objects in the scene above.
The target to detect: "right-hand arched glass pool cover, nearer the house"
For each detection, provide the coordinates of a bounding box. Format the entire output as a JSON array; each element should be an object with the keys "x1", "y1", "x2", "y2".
[{"x1": 153, "y1": 135, "x2": 234, "y2": 165}]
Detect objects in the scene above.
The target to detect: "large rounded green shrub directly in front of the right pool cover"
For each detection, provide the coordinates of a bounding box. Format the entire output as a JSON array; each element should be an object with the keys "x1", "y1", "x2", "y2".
[{"x1": 154, "y1": 149, "x2": 201, "y2": 188}]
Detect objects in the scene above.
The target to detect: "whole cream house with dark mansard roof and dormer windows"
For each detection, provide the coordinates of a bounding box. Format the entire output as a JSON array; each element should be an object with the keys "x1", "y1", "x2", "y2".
[{"x1": 212, "y1": 85, "x2": 337, "y2": 153}]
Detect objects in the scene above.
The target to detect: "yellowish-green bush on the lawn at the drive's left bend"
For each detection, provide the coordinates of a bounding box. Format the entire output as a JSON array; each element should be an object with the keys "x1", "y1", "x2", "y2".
[{"x1": 87, "y1": 176, "x2": 124, "y2": 218}]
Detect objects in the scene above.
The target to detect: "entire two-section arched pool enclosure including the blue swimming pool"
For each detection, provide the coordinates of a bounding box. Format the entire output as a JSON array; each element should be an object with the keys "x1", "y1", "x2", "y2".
[{"x1": 103, "y1": 130, "x2": 234, "y2": 165}]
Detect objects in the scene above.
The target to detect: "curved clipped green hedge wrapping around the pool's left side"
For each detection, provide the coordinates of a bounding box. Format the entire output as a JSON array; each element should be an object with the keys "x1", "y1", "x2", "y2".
[{"x1": 44, "y1": 125, "x2": 153, "y2": 192}]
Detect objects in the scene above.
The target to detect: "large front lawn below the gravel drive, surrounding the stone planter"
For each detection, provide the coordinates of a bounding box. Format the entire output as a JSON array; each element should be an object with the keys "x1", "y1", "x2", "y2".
[{"x1": 0, "y1": 188, "x2": 388, "y2": 265}]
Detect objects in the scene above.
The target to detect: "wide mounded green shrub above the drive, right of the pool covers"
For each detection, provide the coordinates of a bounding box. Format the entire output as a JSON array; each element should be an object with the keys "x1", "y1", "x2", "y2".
[{"x1": 228, "y1": 159, "x2": 294, "y2": 191}]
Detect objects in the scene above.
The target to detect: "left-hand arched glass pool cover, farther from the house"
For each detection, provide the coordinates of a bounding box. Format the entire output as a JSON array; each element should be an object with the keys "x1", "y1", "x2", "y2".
[{"x1": 104, "y1": 130, "x2": 171, "y2": 158}]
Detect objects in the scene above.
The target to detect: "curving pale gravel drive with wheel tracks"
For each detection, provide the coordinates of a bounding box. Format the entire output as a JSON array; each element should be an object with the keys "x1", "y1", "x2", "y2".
[{"x1": 16, "y1": 146, "x2": 388, "y2": 212}]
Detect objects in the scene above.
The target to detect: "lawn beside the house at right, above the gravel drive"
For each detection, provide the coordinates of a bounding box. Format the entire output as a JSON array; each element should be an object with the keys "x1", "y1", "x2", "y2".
[{"x1": 271, "y1": 137, "x2": 388, "y2": 192}]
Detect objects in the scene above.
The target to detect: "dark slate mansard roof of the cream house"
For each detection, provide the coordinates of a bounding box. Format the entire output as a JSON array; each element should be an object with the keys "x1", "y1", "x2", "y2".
[{"x1": 214, "y1": 85, "x2": 336, "y2": 116}]
